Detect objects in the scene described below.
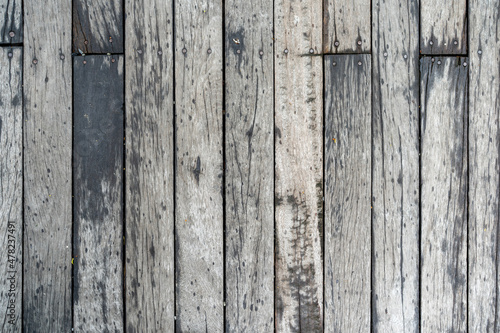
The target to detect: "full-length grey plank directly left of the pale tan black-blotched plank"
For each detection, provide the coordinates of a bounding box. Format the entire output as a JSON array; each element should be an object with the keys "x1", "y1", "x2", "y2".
[{"x1": 225, "y1": 0, "x2": 274, "y2": 332}]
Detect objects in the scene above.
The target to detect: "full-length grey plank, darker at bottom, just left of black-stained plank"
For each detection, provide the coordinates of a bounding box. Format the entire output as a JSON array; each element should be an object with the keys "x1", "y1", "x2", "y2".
[{"x1": 23, "y1": 0, "x2": 72, "y2": 332}]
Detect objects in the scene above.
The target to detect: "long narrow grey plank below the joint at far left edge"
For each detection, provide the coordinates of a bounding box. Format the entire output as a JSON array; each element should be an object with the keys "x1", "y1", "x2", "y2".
[{"x1": 0, "y1": 47, "x2": 23, "y2": 332}]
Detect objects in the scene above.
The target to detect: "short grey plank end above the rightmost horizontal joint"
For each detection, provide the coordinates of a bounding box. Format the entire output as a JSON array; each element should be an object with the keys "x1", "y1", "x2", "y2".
[{"x1": 420, "y1": 0, "x2": 467, "y2": 54}]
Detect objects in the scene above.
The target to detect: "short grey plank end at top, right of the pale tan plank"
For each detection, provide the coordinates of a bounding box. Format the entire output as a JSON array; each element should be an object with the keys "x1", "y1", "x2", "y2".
[{"x1": 324, "y1": 0, "x2": 371, "y2": 53}]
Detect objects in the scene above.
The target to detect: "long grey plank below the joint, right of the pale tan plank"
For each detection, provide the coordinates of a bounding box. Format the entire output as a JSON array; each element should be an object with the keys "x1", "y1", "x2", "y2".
[{"x1": 324, "y1": 55, "x2": 372, "y2": 332}]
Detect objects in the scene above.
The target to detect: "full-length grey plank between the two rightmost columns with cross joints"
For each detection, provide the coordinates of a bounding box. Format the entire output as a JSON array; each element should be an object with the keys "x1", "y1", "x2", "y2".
[{"x1": 372, "y1": 0, "x2": 420, "y2": 333}]
